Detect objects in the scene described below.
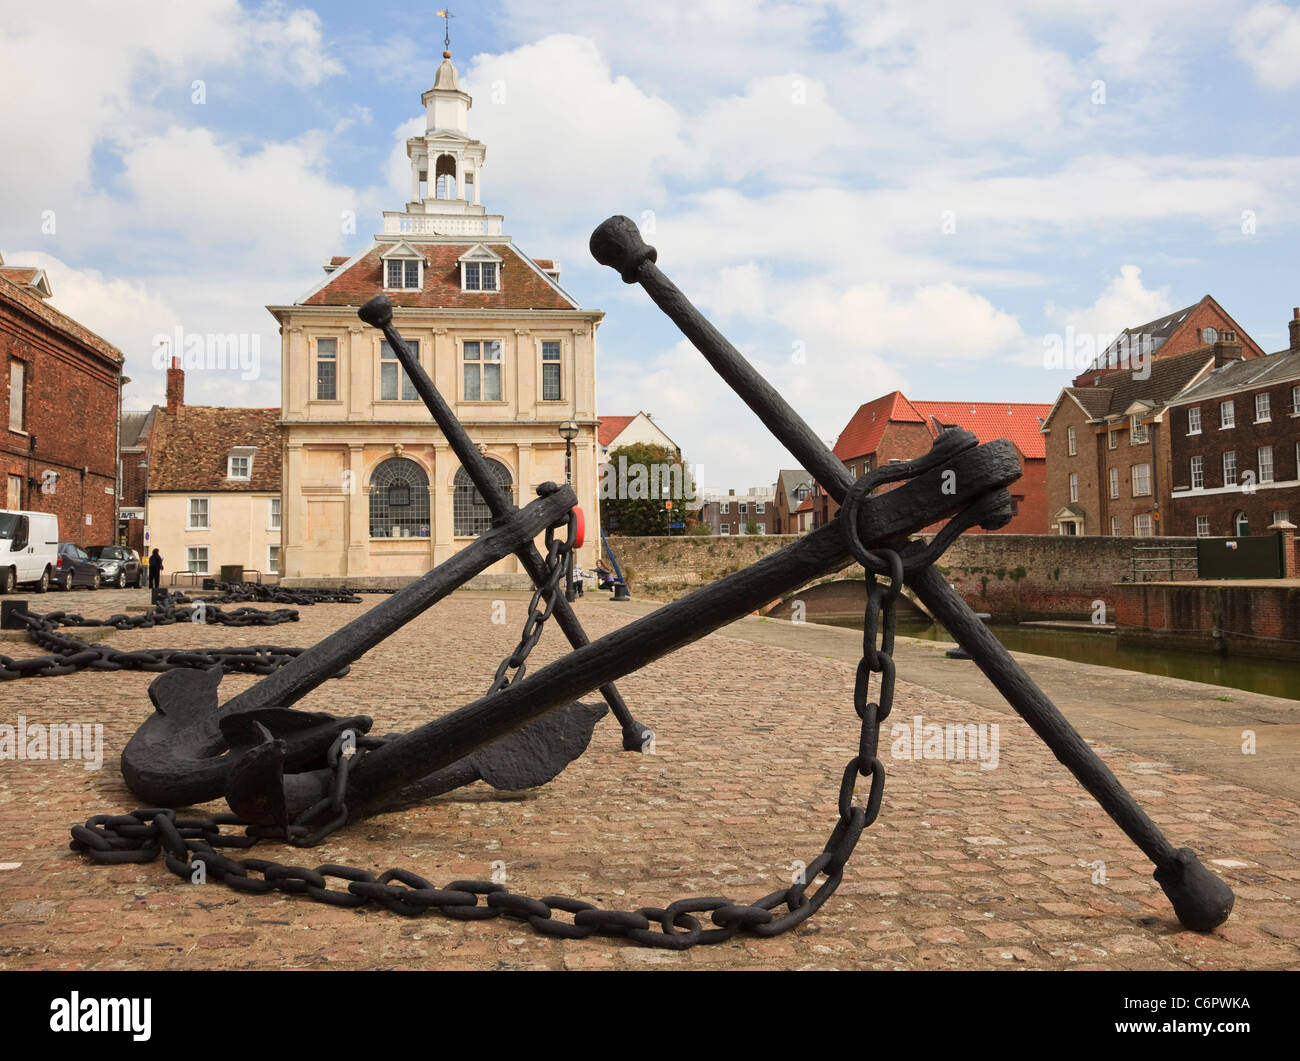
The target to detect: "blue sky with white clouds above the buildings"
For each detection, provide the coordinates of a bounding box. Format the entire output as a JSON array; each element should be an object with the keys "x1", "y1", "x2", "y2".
[{"x1": 0, "y1": 0, "x2": 1300, "y2": 489}]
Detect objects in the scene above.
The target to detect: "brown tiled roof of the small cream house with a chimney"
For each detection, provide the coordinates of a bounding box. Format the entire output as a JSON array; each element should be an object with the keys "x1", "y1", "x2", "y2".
[{"x1": 150, "y1": 406, "x2": 280, "y2": 493}]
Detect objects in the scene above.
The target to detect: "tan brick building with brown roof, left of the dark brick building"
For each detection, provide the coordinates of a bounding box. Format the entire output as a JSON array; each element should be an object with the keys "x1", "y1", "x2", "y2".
[{"x1": 1043, "y1": 332, "x2": 1258, "y2": 537}]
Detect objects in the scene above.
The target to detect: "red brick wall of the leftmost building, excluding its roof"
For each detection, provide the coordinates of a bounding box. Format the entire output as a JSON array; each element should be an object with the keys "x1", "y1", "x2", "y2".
[{"x1": 0, "y1": 303, "x2": 118, "y2": 545}]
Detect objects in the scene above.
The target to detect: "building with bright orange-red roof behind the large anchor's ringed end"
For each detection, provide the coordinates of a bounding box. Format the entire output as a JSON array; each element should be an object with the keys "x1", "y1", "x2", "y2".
[{"x1": 813, "y1": 390, "x2": 1052, "y2": 534}]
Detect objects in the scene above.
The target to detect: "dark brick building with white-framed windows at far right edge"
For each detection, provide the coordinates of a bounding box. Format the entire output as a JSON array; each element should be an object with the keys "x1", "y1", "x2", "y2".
[{"x1": 1166, "y1": 308, "x2": 1300, "y2": 537}]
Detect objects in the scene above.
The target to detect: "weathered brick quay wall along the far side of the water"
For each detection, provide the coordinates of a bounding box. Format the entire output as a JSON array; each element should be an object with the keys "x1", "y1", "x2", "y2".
[{"x1": 610, "y1": 534, "x2": 1192, "y2": 622}]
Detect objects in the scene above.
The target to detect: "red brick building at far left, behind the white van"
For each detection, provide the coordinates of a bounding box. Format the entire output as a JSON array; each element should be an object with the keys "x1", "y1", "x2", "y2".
[{"x1": 0, "y1": 260, "x2": 122, "y2": 545}]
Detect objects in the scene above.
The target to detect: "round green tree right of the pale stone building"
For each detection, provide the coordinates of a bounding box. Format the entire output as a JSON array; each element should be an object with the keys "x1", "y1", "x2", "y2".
[{"x1": 597, "y1": 442, "x2": 699, "y2": 536}]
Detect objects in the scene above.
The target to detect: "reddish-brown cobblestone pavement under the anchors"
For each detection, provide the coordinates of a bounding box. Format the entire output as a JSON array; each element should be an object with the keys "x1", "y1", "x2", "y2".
[{"x1": 0, "y1": 592, "x2": 1300, "y2": 969}]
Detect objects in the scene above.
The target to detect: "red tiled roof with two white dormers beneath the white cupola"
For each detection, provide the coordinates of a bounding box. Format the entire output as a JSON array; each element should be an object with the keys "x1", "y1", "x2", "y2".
[{"x1": 303, "y1": 242, "x2": 573, "y2": 309}]
